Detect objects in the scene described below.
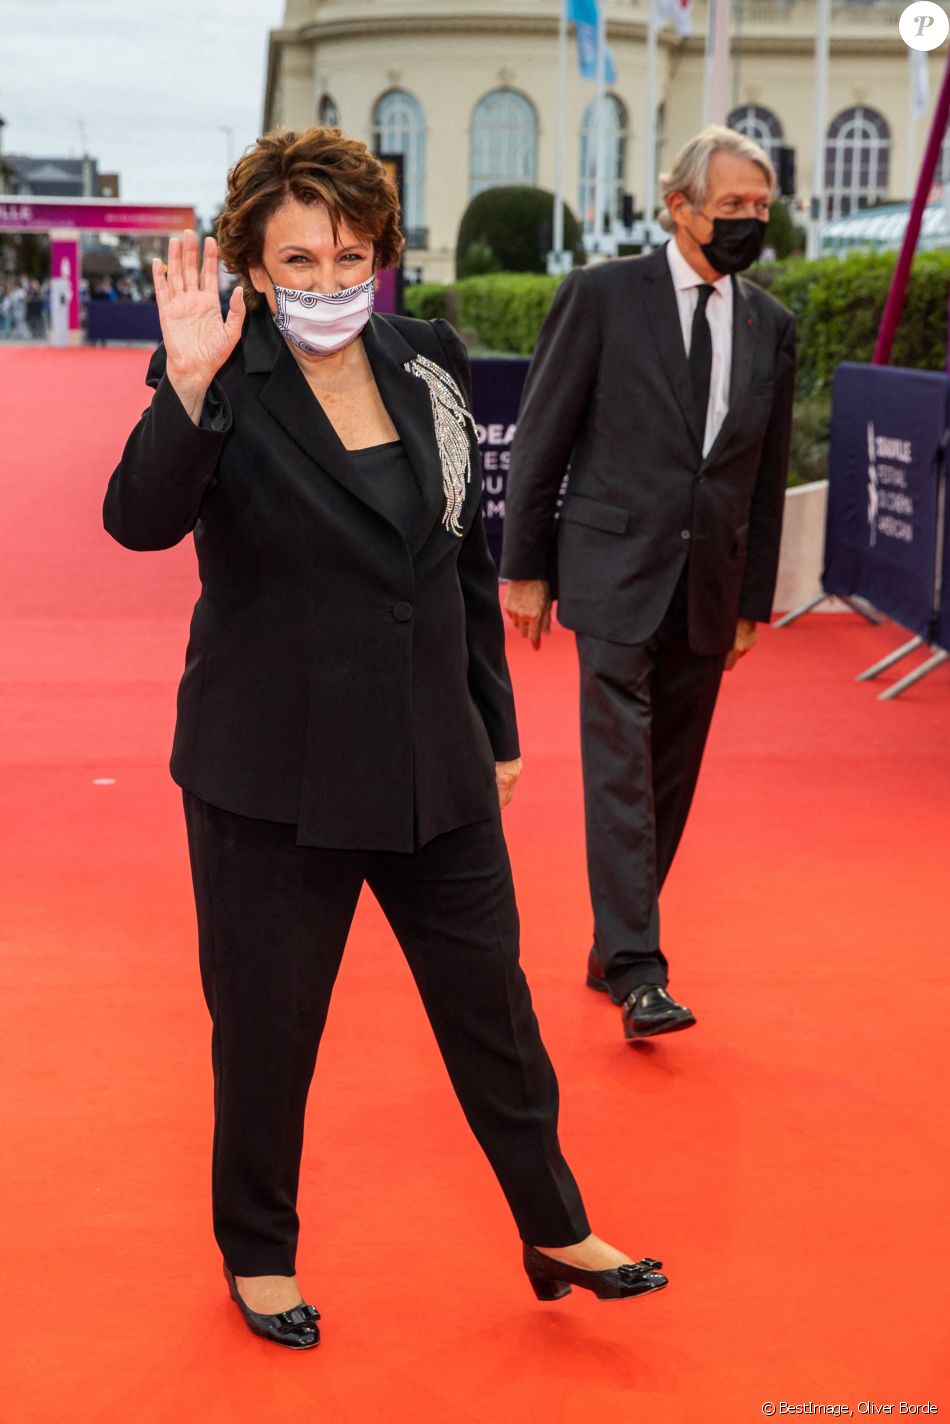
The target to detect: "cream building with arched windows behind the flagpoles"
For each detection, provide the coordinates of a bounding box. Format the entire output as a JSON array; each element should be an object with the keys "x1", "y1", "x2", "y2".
[{"x1": 263, "y1": 0, "x2": 950, "y2": 281}]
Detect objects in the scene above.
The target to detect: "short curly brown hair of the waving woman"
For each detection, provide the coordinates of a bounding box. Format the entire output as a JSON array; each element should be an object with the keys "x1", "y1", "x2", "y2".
[{"x1": 218, "y1": 128, "x2": 404, "y2": 309}]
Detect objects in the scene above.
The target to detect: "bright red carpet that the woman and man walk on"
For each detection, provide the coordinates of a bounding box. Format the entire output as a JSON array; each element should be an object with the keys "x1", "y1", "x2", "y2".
[{"x1": 0, "y1": 350, "x2": 950, "y2": 1424}]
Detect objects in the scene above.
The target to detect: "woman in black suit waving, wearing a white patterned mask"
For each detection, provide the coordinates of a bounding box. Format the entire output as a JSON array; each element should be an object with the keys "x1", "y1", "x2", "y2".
[{"x1": 104, "y1": 128, "x2": 667, "y2": 1349}]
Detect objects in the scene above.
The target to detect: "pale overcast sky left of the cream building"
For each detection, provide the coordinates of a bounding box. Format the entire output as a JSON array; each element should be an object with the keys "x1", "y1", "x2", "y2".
[{"x1": 0, "y1": 0, "x2": 283, "y2": 219}]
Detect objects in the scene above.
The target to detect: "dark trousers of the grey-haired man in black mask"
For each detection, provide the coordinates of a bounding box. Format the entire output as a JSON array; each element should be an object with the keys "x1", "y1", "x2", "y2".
[{"x1": 577, "y1": 571, "x2": 724, "y2": 1002}]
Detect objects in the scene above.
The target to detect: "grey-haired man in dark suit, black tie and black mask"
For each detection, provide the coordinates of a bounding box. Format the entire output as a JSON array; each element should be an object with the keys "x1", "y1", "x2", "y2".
[{"x1": 501, "y1": 127, "x2": 795, "y2": 1040}]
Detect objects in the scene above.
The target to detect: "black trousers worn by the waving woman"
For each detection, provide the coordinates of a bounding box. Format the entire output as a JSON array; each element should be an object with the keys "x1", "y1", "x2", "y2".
[{"x1": 184, "y1": 792, "x2": 590, "y2": 1276}]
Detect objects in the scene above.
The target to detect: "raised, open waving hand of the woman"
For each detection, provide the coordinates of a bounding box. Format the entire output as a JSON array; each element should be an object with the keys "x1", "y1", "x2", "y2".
[{"x1": 152, "y1": 229, "x2": 244, "y2": 422}]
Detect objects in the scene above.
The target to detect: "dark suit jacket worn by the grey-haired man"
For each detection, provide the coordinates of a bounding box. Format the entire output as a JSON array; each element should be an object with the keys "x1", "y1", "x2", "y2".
[{"x1": 501, "y1": 248, "x2": 795, "y2": 654}]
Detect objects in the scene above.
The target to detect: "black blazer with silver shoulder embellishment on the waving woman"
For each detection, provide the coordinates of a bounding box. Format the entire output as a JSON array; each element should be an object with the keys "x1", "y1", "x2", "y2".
[{"x1": 104, "y1": 310, "x2": 518, "y2": 852}]
